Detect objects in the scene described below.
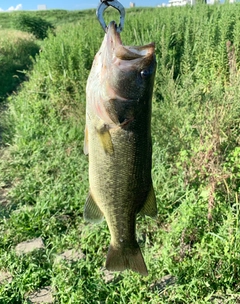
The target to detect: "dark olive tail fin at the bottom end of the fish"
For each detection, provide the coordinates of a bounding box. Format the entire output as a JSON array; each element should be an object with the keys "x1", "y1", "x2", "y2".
[{"x1": 106, "y1": 242, "x2": 148, "y2": 276}]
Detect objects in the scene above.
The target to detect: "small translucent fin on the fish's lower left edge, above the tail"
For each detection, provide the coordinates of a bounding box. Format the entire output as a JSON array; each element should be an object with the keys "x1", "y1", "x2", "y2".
[{"x1": 83, "y1": 192, "x2": 104, "y2": 223}]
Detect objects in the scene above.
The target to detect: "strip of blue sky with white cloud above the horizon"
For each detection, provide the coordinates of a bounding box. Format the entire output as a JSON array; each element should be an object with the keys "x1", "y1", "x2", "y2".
[{"x1": 0, "y1": 0, "x2": 161, "y2": 11}]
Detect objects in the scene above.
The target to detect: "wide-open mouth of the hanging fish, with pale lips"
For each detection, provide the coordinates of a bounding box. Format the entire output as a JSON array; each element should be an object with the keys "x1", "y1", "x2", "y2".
[{"x1": 107, "y1": 21, "x2": 155, "y2": 60}]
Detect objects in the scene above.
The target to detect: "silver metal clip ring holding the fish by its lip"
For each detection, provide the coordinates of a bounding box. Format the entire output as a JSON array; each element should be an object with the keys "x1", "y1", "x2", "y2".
[{"x1": 96, "y1": 0, "x2": 125, "y2": 33}]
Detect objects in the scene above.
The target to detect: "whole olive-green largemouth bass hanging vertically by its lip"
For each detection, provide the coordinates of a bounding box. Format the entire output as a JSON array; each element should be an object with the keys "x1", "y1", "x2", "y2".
[{"x1": 83, "y1": 21, "x2": 157, "y2": 276}]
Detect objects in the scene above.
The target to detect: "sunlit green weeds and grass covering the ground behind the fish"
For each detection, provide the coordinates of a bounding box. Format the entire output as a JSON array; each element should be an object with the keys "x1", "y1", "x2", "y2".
[{"x1": 0, "y1": 4, "x2": 240, "y2": 304}]
